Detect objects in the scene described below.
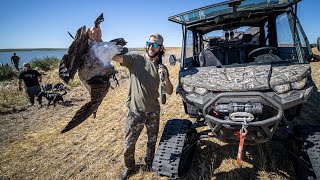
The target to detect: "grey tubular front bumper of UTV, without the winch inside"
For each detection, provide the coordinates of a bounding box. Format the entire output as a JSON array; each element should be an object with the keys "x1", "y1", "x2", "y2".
[{"x1": 203, "y1": 92, "x2": 284, "y2": 144}]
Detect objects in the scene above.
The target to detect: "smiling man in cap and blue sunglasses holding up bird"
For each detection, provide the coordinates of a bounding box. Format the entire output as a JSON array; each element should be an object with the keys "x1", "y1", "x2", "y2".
[{"x1": 112, "y1": 33, "x2": 173, "y2": 179}]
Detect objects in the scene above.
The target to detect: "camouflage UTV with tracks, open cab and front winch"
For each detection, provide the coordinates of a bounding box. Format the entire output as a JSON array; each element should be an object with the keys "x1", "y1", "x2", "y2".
[{"x1": 153, "y1": 0, "x2": 316, "y2": 179}]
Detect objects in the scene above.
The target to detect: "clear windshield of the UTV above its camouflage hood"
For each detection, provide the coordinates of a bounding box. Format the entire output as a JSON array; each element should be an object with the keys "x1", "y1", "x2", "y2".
[{"x1": 183, "y1": 5, "x2": 311, "y2": 67}]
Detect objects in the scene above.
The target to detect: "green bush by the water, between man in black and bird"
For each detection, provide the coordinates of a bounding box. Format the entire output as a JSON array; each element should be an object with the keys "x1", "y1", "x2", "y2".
[{"x1": 30, "y1": 56, "x2": 60, "y2": 71}]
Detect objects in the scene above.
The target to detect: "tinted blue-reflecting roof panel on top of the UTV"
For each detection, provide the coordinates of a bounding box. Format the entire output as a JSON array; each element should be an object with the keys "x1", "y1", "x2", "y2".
[{"x1": 169, "y1": 0, "x2": 301, "y2": 26}]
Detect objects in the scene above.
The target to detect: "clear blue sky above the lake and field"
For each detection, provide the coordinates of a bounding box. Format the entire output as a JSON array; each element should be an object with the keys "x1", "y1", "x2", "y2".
[{"x1": 0, "y1": 0, "x2": 320, "y2": 49}]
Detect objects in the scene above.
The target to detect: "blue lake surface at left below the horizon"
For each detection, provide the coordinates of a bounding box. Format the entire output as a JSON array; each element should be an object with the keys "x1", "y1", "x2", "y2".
[{"x1": 0, "y1": 49, "x2": 67, "y2": 66}]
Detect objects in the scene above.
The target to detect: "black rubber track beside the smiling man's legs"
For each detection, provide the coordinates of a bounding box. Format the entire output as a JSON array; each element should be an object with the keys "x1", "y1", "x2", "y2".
[{"x1": 152, "y1": 119, "x2": 191, "y2": 179}]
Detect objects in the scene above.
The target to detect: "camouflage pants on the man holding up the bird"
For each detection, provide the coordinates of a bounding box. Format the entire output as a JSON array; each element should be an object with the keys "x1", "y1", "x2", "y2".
[{"x1": 124, "y1": 110, "x2": 160, "y2": 169}]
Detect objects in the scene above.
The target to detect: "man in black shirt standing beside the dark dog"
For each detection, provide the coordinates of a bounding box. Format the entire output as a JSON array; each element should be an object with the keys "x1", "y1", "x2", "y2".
[{"x1": 18, "y1": 63, "x2": 42, "y2": 108}]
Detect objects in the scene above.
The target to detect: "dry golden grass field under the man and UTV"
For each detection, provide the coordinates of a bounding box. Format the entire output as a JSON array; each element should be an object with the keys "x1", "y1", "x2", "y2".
[{"x1": 0, "y1": 49, "x2": 320, "y2": 179}]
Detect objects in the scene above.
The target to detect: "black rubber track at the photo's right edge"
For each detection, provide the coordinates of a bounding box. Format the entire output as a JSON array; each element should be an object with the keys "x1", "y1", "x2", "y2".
[{"x1": 299, "y1": 125, "x2": 320, "y2": 179}]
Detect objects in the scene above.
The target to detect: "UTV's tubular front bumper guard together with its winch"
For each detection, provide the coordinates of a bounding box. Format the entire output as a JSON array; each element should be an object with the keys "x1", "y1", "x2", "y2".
[{"x1": 203, "y1": 92, "x2": 284, "y2": 144}]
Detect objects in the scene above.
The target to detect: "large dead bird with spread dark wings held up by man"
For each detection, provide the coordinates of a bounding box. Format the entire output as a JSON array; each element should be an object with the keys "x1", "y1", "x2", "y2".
[{"x1": 59, "y1": 26, "x2": 128, "y2": 133}]
